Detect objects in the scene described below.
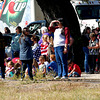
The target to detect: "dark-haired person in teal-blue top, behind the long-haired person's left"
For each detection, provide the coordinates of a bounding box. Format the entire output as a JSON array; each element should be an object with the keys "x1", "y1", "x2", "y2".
[{"x1": 11, "y1": 26, "x2": 22, "y2": 58}]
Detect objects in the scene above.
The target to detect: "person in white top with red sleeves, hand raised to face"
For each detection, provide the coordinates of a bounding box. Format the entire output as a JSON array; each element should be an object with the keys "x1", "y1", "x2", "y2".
[{"x1": 49, "y1": 18, "x2": 70, "y2": 79}]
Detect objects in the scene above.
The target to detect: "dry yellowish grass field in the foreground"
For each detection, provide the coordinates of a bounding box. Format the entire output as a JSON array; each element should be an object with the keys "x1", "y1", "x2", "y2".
[{"x1": 0, "y1": 80, "x2": 100, "y2": 100}]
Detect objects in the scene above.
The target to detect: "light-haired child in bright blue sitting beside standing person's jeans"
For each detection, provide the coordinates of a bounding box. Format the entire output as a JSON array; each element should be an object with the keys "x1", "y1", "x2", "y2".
[{"x1": 47, "y1": 54, "x2": 58, "y2": 75}]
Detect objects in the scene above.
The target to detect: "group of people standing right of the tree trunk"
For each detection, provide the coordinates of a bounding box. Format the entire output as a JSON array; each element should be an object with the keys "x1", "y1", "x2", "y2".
[{"x1": 82, "y1": 27, "x2": 100, "y2": 74}]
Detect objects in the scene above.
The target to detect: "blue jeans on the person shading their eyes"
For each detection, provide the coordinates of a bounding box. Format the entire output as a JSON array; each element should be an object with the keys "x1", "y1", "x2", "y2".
[{"x1": 54, "y1": 46, "x2": 68, "y2": 77}]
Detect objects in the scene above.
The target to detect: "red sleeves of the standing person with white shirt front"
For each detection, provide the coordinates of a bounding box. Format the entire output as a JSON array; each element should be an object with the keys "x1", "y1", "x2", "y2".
[{"x1": 48, "y1": 27, "x2": 70, "y2": 45}]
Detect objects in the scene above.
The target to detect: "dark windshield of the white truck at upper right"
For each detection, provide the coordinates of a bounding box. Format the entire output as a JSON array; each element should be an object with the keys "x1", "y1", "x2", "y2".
[{"x1": 76, "y1": 5, "x2": 100, "y2": 19}]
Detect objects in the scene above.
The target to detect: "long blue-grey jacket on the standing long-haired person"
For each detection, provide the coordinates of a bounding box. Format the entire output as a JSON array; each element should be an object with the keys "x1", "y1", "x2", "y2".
[{"x1": 20, "y1": 36, "x2": 33, "y2": 60}]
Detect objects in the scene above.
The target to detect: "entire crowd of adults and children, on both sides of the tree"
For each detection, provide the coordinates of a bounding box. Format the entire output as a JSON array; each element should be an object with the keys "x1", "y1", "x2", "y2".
[{"x1": 0, "y1": 19, "x2": 97, "y2": 80}]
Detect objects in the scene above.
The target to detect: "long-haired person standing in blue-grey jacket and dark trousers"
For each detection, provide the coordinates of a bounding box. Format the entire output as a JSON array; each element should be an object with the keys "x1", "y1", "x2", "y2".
[{"x1": 19, "y1": 27, "x2": 33, "y2": 80}]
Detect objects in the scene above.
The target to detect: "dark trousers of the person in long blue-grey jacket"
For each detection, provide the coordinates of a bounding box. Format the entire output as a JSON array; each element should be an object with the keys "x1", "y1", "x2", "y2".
[{"x1": 21, "y1": 60, "x2": 33, "y2": 79}]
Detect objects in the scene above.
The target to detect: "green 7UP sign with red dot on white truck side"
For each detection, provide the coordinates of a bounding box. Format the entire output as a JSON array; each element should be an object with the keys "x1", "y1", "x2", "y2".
[{"x1": 0, "y1": 0, "x2": 28, "y2": 27}]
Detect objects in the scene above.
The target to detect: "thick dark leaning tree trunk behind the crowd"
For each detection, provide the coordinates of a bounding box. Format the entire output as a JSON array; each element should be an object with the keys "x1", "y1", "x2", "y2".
[{"x1": 36, "y1": 0, "x2": 82, "y2": 69}]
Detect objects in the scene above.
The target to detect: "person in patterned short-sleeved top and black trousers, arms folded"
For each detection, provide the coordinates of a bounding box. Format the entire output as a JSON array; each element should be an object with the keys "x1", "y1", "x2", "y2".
[{"x1": 88, "y1": 33, "x2": 99, "y2": 74}]
